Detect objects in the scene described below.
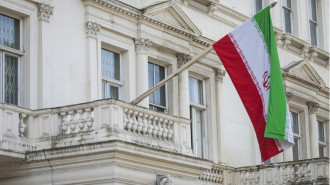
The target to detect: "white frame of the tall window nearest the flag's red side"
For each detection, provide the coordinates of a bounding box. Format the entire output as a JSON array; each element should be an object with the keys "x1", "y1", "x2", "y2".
[{"x1": 188, "y1": 75, "x2": 208, "y2": 159}]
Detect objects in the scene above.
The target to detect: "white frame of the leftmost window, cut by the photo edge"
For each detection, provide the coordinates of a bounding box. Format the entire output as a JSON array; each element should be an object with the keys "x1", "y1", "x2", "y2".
[{"x1": 0, "y1": 12, "x2": 24, "y2": 106}]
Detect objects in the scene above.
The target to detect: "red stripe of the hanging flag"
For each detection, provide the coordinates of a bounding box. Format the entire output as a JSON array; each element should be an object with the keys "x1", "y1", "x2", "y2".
[{"x1": 213, "y1": 35, "x2": 283, "y2": 161}]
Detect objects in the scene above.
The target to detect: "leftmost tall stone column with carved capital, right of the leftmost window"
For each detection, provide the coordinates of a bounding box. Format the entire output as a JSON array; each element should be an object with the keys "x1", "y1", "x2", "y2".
[{"x1": 38, "y1": 3, "x2": 54, "y2": 108}]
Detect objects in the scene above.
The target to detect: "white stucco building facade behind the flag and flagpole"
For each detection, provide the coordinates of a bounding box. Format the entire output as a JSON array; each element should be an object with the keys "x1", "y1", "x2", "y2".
[{"x1": 0, "y1": 0, "x2": 330, "y2": 185}]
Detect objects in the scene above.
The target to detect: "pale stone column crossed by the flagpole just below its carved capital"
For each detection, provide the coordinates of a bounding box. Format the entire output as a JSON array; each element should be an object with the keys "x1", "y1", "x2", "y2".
[{"x1": 176, "y1": 53, "x2": 191, "y2": 119}]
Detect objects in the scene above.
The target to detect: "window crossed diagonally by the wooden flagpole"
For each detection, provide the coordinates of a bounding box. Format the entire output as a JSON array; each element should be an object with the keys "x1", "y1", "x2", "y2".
[{"x1": 148, "y1": 62, "x2": 166, "y2": 112}]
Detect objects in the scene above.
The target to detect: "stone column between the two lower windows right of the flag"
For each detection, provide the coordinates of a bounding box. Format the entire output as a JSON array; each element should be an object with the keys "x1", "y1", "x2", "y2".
[{"x1": 307, "y1": 102, "x2": 320, "y2": 158}]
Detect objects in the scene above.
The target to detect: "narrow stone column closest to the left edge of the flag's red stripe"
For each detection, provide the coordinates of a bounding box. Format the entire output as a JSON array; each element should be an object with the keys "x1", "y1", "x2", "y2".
[{"x1": 214, "y1": 69, "x2": 226, "y2": 163}]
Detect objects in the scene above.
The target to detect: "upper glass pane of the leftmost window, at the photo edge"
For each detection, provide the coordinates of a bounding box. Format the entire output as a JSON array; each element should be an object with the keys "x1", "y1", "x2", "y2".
[{"x1": 0, "y1": 14, "x2": 20, "y2": 49}]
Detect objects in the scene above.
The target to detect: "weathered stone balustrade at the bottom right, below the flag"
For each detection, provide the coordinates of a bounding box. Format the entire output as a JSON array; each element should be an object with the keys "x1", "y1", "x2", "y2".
[{"x1": 198, "y1": 158, "x2": 329, "y2": 185}]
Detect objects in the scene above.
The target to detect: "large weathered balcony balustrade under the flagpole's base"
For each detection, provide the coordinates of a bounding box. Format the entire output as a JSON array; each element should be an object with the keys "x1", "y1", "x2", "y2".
[{"x1": 0, "y1": 99, "x2": 193, "y2": 163}]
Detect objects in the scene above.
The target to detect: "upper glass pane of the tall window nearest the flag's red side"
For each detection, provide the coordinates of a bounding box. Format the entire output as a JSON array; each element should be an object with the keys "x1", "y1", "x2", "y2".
[{"x1": 189, "y1": 77, "x2": 204, "y2": 105}]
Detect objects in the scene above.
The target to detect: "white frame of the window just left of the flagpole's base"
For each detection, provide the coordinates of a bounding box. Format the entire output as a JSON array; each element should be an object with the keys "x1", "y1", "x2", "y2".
[{"x1": 100, "y1": 45, "x2": 124, "y2": 100}]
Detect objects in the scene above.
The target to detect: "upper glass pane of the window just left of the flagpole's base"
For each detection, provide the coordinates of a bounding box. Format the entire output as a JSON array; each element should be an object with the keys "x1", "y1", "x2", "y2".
[{"x1": 101, "y1": 49, "x2": 120, "y2": 80}]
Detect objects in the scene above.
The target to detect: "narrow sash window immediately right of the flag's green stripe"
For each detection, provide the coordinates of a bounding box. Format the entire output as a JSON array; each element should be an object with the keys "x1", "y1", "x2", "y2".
[{"x1": 290, "y1": 112, "x2": 301, "y2": 161}]
